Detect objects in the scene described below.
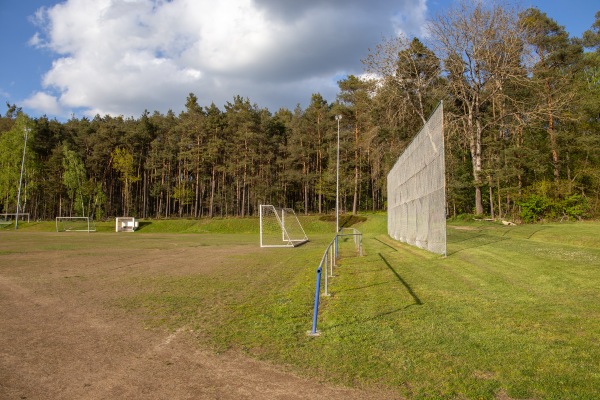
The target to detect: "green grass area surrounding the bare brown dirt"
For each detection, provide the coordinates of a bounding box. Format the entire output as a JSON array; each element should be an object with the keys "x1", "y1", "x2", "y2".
[{"x1": 0, "y1": 214, "x2": 600, "y2": 399}]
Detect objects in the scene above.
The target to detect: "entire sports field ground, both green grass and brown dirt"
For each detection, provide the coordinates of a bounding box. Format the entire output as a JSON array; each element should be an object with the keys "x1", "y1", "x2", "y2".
[{"x1": 0, "y1": 214, "x2": 600, "y2": 399}]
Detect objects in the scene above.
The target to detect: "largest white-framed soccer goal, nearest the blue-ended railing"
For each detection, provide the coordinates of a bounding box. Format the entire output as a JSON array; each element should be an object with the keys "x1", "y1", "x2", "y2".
[{"x1": 260, "y1": 204, "x2": 308, "y2": 247}]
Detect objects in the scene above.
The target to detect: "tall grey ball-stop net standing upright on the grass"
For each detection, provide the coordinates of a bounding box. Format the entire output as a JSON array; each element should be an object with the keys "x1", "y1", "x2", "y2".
[{"x1": 387, "y1": 103, "x2": 446, "y2": 255}]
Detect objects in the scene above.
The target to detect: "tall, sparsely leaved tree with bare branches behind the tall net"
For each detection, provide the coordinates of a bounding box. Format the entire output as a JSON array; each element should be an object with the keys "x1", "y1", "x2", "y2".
[{"x1": 429, "y1": 1, "x2": 524, "y2": 214}]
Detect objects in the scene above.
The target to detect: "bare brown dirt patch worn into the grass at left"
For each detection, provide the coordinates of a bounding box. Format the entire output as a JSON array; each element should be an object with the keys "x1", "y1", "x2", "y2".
[{"x1": 0, "y1": 233, "x2": 394, "y2": 399}]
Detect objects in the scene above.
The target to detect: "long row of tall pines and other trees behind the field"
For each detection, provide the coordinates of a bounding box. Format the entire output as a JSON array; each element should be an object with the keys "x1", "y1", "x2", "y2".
[{"x1": 0, "y1": 2, "x2": 600, "y2": 220}]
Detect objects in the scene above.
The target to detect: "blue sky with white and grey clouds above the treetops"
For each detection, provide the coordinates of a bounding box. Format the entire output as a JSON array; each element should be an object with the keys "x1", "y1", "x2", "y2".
[{"x1": 0, "y1": 0, "x2": 600, "y2": 120}]
